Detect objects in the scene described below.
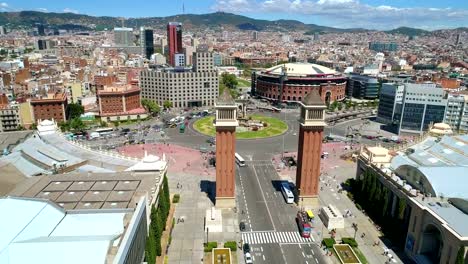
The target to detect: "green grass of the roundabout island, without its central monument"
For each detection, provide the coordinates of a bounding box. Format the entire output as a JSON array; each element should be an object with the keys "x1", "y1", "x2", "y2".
[{"x1": 193, "y1": 115, "x2": 288, "y2": 139}]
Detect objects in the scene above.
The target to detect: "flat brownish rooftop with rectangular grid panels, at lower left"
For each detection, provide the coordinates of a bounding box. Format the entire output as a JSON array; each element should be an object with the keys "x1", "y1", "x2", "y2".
[{"x1": 10, "y1": 172, "x2": 159, "y2": 209}]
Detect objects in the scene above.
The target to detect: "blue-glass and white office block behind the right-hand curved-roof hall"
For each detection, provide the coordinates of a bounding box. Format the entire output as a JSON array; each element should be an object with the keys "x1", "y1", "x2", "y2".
[{"x1": 377, "y1": 83, "x2": 447, "y2": 134}]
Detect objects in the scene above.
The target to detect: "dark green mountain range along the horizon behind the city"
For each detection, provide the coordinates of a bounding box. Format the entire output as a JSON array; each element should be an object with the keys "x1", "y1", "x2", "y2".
[{"x1": 0, "y1": 11, "x2": 467, "y2": 36}]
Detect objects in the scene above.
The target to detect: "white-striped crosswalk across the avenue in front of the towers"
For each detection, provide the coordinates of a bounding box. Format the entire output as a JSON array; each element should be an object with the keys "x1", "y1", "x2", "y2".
[{"x1": 242, "y1": 231, "x2": 315, "y2": 244}]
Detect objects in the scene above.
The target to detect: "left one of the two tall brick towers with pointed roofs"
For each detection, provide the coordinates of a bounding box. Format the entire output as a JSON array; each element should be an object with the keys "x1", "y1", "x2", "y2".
[{"x1": 214, "y1": 89, "x2": 238, "y2": 208}]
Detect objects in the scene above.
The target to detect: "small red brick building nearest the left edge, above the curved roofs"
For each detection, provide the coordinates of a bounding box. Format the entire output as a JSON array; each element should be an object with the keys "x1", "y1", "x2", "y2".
[{"x1": 31, "y1": 92, "x2": 68, "y2": 122}]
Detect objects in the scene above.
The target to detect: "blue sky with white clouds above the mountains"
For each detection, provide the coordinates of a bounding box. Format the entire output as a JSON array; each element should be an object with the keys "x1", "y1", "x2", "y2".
[{"x1": 0, "y1": 0, "x2": 468, "y2": 29}]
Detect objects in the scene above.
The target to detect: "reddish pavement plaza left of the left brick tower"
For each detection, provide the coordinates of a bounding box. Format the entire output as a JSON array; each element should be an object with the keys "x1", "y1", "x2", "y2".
[{"x1": 117, "y1": 143, "x2": 215, "y2": 176}]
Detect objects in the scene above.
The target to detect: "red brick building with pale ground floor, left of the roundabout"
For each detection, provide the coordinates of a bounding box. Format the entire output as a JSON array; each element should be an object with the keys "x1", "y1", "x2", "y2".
[{"x1": 97, "y1": 85, "x2": 147, "y2": 121}]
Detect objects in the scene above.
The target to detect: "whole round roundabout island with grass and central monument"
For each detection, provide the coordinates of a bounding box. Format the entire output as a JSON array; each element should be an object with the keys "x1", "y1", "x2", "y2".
[{"x1": 193, "y1": 114, "x2": 288, "y2": 139}]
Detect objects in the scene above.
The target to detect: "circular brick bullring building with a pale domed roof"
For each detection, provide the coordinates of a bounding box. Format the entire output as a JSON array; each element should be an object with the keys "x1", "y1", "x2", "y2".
[{"x1": 252, "y1": 63, "x2": 346, "y2": 103}]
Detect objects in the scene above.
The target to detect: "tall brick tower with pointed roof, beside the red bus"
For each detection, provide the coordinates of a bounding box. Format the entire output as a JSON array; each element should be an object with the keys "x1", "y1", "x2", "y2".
[{"x1": 296, "y1": 90, "x2": 326, "y2": 207}]
